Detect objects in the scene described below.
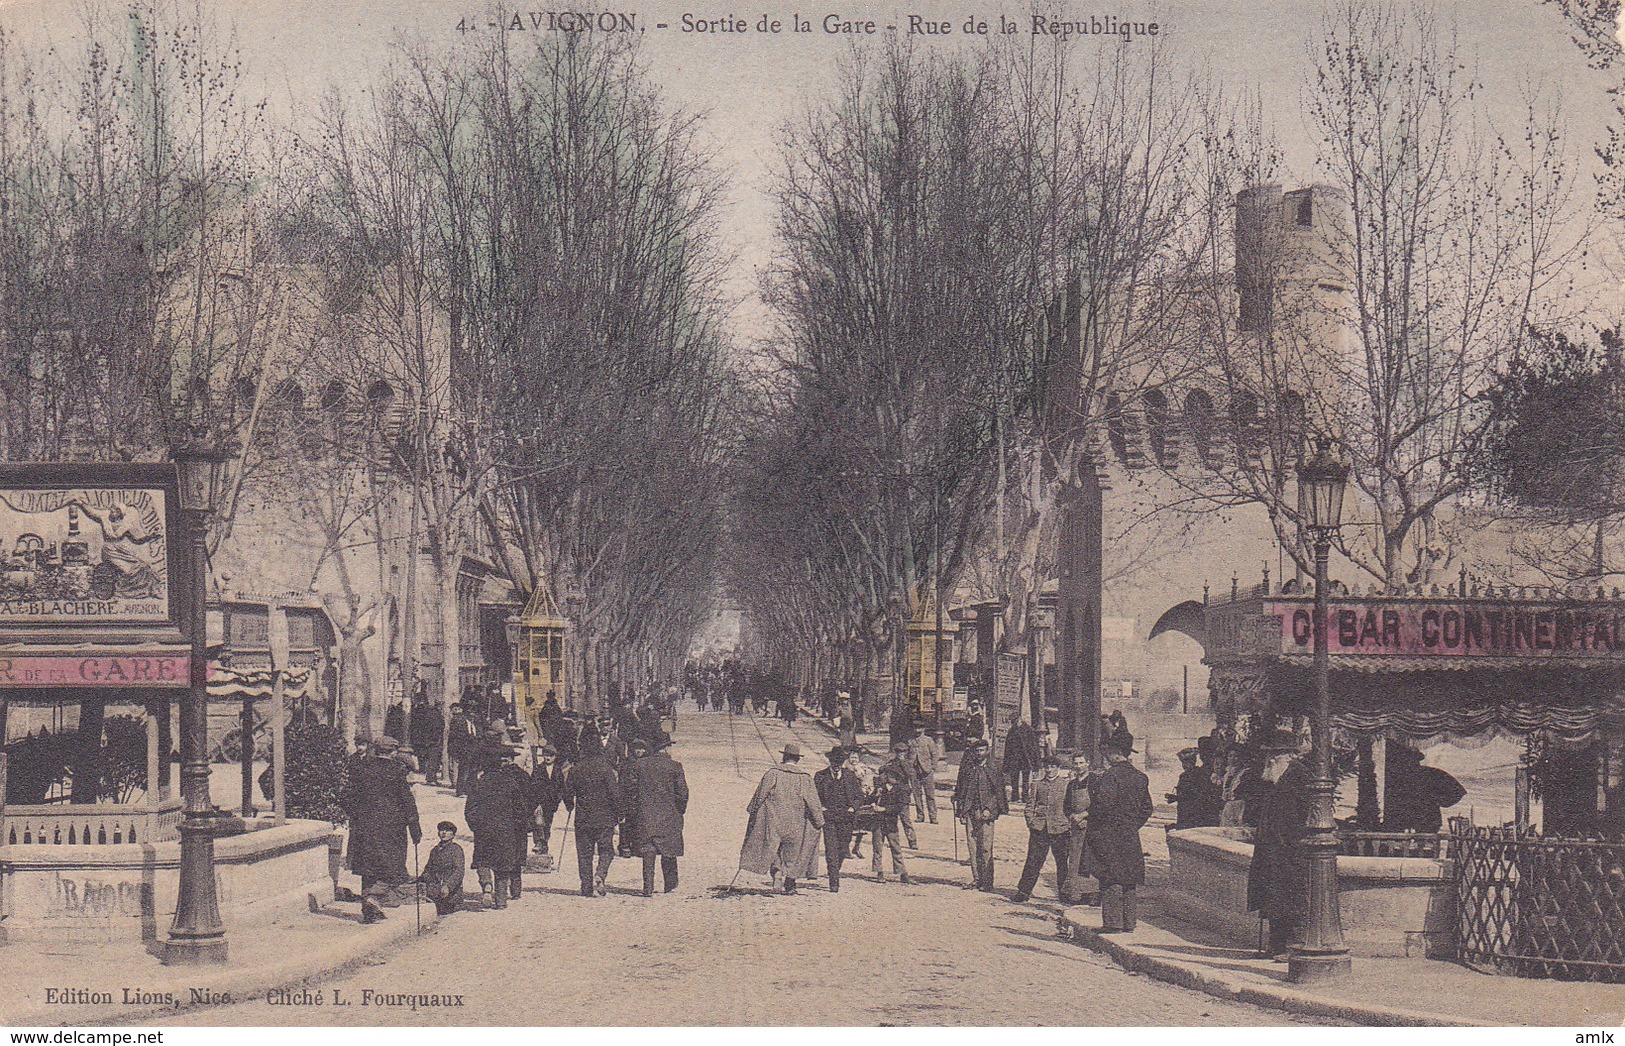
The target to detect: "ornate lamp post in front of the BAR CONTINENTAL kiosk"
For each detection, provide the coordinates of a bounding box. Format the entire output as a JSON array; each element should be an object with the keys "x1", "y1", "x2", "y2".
[{"x1": 1287, "y1": 439, "x2": 1349, "y2": 983}]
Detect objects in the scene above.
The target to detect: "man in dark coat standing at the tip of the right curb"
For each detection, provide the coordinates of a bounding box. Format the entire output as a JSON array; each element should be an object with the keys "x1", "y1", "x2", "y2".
[{"x1": 1084, "y1": 737, "x2": 1152, "y2": 934}]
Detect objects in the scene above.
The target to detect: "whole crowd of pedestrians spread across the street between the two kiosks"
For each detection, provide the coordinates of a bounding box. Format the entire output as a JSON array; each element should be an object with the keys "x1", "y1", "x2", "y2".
[{"x1": 345, "y1": 675, "x2": 1464, "y2": 958}]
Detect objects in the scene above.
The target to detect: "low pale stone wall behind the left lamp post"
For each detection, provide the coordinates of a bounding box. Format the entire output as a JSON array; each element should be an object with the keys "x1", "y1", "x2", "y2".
[{"x1": 0, "y1": 820, "x2": 335, "y2": 942}]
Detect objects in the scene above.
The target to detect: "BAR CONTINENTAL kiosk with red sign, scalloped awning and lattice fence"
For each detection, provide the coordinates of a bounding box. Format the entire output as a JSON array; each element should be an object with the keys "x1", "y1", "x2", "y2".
[{"x1": 1154, "y1": 583, "x2": 1625, "y2": 979}]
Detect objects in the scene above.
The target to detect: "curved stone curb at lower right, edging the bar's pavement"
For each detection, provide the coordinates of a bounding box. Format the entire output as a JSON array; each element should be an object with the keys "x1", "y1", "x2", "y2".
[{"x1": 1061, "y1": 913, "x2": 1500, "y2": 1028}]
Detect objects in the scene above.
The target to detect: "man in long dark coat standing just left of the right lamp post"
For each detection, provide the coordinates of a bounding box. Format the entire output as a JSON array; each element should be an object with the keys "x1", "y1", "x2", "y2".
[{"x1": 1246, "y1": 737, "x2": 1310, "y2": 962}]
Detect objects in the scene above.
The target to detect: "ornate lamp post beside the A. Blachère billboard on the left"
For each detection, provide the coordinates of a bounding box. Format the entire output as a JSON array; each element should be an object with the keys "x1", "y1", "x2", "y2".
[{"x1": 164, "y1": 439, "x2": 237, "y2": 966}]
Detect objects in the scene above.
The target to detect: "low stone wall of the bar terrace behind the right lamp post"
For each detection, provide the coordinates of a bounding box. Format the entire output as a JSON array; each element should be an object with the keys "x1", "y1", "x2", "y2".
[{"x1": 1164, "y1": 828, "x2": 1456, "y2": 958}]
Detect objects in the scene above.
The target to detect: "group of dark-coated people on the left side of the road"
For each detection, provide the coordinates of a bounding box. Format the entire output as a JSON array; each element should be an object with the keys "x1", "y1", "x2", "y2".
[{"x1": 341, "y1": 689, "x2": 689, "y2": 923}]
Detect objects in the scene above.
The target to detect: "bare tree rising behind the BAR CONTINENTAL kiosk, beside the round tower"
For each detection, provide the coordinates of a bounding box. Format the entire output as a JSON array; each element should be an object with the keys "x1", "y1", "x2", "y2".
[{"x1": 1212, "y1": 3, "x2": 1576, "y2": 585}]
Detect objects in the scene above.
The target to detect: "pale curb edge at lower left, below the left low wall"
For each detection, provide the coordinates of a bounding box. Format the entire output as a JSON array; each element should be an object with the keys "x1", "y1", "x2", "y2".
[{"x1": 0, "y1": 906, "x2": 440, "y2": 1028}]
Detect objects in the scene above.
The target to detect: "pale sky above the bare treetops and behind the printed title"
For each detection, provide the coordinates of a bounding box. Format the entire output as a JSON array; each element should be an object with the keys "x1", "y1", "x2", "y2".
[{"x1": 0, "y1": 0, "x2": 1612, "y2": 333}]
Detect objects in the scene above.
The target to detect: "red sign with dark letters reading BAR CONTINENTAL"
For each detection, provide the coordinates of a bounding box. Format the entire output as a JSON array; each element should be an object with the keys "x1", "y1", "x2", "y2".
[{"x1": 1263, "y1": 599, "x2": 1625, "y2": 659}]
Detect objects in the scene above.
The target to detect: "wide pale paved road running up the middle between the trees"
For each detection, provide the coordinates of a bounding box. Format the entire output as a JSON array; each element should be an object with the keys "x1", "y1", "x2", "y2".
[{"x1": 172, "y1": 711, "x2": 1313, "y2": 1025}]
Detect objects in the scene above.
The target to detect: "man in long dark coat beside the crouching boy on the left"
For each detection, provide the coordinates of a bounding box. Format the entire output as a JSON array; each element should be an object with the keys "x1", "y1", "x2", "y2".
[{"x1": 341, "y1": 737, "x2": 423, "y2": 923}]
